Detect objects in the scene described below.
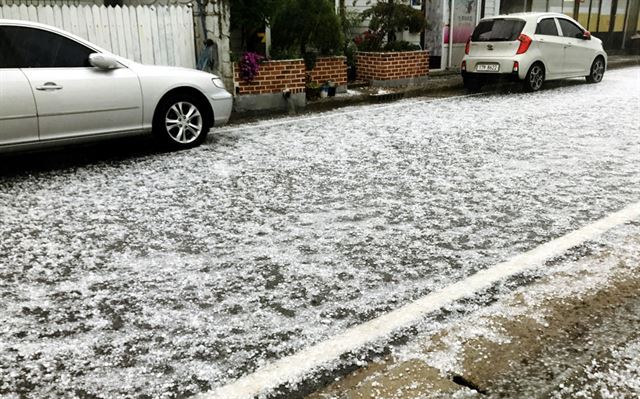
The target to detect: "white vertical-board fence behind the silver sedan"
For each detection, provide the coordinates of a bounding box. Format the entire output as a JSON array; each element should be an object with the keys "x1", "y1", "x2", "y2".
[{"x1": 0, "y1": 4, "x2": 196, "y2": 68}]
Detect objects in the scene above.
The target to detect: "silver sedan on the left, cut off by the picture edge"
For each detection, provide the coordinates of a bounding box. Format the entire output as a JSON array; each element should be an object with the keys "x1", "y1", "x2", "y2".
[{"x1": 0, "y1": 20, "x2": 233, "y2": 152}]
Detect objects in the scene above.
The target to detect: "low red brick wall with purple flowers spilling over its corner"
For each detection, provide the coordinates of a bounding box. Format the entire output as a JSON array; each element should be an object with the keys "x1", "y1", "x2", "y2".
[{"x1": 234, "y1": 59, "x2": 305, "y2": 95}]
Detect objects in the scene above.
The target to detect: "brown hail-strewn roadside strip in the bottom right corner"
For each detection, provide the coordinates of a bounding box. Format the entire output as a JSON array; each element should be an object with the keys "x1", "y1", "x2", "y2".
[{"x1": 308, "y1": 231, "x2": 640, "y2": 399}]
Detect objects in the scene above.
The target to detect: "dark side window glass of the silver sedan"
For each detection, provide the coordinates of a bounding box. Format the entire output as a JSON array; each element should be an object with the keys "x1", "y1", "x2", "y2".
[{"x1": 0, "y1": 26, "x2": 94, "y2": 68}]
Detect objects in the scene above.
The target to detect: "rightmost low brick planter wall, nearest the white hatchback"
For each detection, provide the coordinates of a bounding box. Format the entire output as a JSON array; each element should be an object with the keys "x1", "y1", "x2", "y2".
[{"x1": 356, "y1": 50, "x2": 429, "y2": 80}]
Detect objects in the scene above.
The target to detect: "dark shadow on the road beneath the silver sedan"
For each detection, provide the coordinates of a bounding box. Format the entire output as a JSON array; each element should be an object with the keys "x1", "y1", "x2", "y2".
[{"x1": 0, "y1": 136, "x2": 166, "y2": 178}]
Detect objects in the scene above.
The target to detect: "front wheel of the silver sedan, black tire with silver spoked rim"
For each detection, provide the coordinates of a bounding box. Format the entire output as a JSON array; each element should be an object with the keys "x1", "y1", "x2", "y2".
[{"x1": 153, "y1": 93, "x2": 212, "y2": 150}]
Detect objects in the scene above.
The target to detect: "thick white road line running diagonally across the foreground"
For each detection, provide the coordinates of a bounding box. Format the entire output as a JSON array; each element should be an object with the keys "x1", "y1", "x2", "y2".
[{"x1": 200, "y1": 202, "x2": 640, "y2": 399}]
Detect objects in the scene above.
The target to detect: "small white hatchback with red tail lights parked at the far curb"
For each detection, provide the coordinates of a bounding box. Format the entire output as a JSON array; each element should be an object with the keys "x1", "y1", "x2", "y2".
[{"x1": 461, "y1": 13, "x2": 607, "y2": 91}]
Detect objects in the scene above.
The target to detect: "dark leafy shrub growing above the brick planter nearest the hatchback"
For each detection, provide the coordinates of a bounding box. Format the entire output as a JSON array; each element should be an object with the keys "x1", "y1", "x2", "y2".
[{"x1": 362, "y1": 0, "x2": 427, "y2": 43}]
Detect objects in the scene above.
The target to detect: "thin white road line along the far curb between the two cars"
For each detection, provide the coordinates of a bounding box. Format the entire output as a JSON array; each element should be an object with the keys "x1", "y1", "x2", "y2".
[{"x1": 212, "y1": 93, "x2": 486, "y2": 134}]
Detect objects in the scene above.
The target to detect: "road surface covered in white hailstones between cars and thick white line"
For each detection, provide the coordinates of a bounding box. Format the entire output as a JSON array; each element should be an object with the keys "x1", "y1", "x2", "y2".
[{"x1": 0, "y1": 68, "x2": 640, "y2": 398}]
